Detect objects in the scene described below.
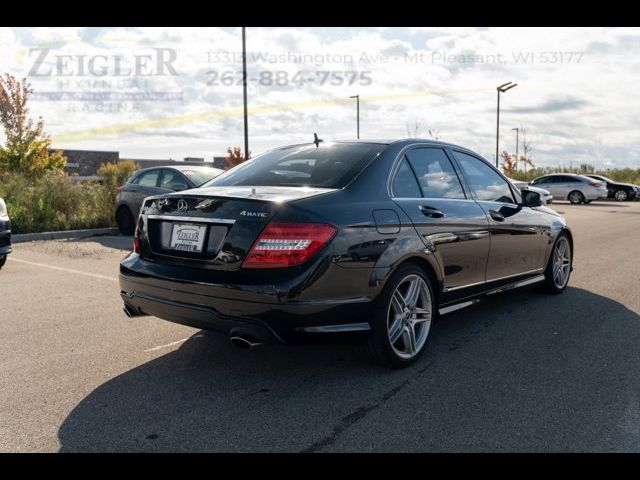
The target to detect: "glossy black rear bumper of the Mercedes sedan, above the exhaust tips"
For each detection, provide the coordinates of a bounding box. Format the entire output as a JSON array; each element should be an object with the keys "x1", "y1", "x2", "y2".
[{"x1": 120, "y1": 255, "x2": 372, "y2": 343}]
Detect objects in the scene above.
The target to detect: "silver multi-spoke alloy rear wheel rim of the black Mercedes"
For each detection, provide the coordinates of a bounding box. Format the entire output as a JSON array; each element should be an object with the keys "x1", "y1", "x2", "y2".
[{"x1": 387, "y1": 274, "x2": 432, "y2": 359}]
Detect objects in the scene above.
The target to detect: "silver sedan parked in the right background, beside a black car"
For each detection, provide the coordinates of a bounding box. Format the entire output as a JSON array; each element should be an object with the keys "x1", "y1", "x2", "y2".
[{"x1": 529, "y1": 173, "x2": 607, "y2": 204}]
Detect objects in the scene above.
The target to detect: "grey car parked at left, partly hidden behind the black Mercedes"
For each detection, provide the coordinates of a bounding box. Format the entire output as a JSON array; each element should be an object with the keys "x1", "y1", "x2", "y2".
[{"x1": 116, "y1": 165, "x2": 224, "y2": 235}]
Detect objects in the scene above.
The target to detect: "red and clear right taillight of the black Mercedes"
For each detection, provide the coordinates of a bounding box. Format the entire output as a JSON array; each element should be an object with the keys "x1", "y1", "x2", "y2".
[{"x1": 242, "y1": 222, "x2": 337, "y2": 268}]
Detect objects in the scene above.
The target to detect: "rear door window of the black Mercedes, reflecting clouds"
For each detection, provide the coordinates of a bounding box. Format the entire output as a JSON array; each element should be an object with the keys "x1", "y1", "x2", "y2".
[{"x1": 407, "y1": 148, "x2": 466, "y2": 198}]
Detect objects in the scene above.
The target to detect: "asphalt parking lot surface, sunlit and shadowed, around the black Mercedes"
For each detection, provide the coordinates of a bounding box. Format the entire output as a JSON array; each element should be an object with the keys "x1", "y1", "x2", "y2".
[{"x1": 0, "y1": 202, "x2": 640, "y2": 452}]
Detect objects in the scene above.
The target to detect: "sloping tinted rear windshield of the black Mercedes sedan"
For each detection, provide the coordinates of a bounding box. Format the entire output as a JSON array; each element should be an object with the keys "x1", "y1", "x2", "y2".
[{"x1": 204, "y1": 143, "x2": 386, "y2": 188}]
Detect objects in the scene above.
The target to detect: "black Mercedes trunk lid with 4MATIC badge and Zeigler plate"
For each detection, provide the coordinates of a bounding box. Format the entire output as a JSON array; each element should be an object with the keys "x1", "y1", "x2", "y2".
[{"x1": 140, "y1": 186, "x2": 334, "y2": 270}]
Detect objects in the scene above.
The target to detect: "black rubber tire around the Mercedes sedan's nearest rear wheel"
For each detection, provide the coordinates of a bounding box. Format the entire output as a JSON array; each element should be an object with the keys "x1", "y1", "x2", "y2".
[{"x1": 364, "y1": 263, "x2": 437, "y2": 368}]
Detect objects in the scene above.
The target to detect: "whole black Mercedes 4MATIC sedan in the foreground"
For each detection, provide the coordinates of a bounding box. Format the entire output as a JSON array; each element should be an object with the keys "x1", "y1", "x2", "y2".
[{"x1": 120, "y1": 139, "x2": 573, "y2": 367}]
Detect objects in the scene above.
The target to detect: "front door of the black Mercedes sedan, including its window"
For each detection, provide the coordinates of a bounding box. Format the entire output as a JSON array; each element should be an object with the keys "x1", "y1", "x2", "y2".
[{"x1": 453, "y1": 150, "x2": 547, "y2": 283}]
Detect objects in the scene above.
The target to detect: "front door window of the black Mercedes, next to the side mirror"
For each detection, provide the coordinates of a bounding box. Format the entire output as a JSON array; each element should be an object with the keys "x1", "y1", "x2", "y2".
[{"x1": 453, "y1": 151, "x2": 515, "y2": 203}]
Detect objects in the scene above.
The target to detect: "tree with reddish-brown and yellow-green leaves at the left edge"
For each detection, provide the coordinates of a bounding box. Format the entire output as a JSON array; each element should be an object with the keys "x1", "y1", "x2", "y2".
[{"x1": 0, "y1": 73, "x2": 67, "y2": 178}]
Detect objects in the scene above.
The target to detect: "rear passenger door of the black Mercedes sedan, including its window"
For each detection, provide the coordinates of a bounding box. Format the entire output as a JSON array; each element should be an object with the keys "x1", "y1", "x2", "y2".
[{"x1": 391, "y1": 147, "x2": 489, "y2": 292}]
